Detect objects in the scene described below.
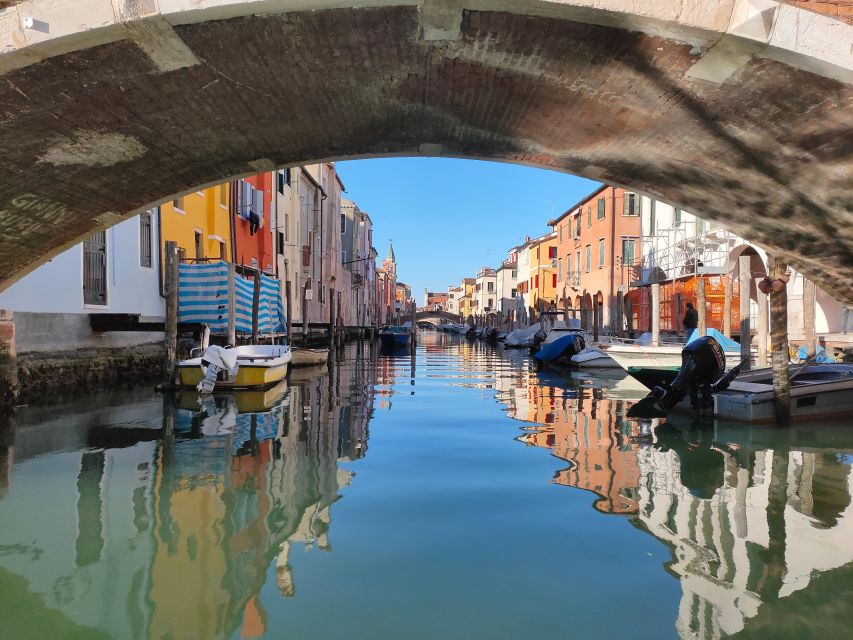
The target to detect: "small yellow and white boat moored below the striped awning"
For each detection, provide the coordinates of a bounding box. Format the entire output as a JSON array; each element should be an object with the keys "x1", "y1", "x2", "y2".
[{"x1": 178, "y1": 344, "x2": 292, "y2": 391}]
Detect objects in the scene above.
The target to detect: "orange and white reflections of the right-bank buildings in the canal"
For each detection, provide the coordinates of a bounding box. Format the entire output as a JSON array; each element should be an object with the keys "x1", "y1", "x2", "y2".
[{"x1": 498, "y1": 358, "x2": 853, "y2": 639}]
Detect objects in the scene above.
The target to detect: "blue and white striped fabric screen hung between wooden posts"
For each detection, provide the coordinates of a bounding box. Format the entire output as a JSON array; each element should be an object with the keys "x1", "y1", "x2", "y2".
[{"x1": 178, "y1": 262, "x2": 286, "y2": 335}]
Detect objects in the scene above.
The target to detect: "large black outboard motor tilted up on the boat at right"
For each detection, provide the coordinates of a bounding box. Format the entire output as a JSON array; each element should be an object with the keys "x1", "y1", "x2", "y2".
[{"x1": 628, "y1": 336, "x2": 743, "y2": 418}]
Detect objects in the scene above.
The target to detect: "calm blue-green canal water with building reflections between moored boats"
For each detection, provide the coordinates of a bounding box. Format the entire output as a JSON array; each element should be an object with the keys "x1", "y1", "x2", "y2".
[{"x1": 0, "y1": 333, "x2": 853, "y2": 640}]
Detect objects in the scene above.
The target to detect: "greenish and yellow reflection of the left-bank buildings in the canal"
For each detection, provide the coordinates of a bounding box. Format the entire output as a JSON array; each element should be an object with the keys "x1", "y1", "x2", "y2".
[{"x1": 0, "y1": 358, "x2": 372, "y2": 638}]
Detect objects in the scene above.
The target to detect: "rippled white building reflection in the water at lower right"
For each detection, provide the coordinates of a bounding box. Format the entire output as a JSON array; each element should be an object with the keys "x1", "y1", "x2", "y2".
[{"x1": 637, "y1": 427, "x2": 853, "y2": 638}]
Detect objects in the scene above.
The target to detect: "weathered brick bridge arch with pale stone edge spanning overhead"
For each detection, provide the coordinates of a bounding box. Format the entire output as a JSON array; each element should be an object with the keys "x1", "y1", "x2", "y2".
[{"x1": 0, "y1": 0, "x2": 853, "y2": 300}]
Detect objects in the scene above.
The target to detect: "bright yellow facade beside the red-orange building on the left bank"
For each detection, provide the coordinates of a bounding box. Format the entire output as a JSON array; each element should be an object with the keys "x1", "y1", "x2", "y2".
[{"x1": 160, "y1": 182, "x2": 231, "y2": 262}]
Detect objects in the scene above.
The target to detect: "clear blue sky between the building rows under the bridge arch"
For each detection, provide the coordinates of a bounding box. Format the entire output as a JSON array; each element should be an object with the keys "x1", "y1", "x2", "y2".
[{"x1": 336, "y1": 158, "x2": 598, "y2": 304}]
